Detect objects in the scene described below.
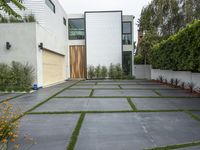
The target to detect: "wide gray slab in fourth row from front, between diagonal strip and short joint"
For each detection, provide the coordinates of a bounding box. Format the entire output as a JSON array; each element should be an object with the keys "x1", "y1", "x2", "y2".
[{"x1": 71, "y1": 85, "x2": 119, "y2": 89}]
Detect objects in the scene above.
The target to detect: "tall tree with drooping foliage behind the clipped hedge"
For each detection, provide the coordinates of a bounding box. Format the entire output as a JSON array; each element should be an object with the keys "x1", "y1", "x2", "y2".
[{"x1": 137, "y1": 0, "x2": 200, "y2": 60}]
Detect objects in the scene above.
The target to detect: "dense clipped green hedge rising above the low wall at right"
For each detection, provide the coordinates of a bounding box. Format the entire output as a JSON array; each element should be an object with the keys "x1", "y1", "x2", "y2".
[{"x1": 150, "y1": 20, "x2": 200, "y2": 72}]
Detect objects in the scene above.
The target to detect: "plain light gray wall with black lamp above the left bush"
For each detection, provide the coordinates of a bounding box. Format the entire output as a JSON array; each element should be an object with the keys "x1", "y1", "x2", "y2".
[{"x1": 0, "y1": 23, "x2": 38, "y2": 83}]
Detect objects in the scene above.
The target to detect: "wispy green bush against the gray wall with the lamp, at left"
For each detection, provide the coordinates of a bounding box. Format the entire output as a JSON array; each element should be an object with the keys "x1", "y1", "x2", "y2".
[{"x1": 0, "y1": 61, "x2": 34, "y2": 91}]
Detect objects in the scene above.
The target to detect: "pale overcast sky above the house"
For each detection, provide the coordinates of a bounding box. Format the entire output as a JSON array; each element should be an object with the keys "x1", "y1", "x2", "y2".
[{"x1": 59, "y1": 0, "x2": 151, "y2": 40}]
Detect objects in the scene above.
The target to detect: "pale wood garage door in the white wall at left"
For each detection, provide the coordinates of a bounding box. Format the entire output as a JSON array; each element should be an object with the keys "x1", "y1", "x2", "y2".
[{"x1": 42, "y1": 50, "x2": 65, "y2": 86}]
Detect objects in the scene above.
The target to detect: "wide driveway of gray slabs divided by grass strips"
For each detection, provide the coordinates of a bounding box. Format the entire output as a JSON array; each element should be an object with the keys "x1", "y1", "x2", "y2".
[{"x1": 5, "y1": 80, "x2": 200, "y2": 150}]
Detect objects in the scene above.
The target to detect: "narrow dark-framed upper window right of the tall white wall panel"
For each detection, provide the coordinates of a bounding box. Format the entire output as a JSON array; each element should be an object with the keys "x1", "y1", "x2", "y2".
[{"x1": 122, "y1": 21, "x2": 132, "y2": 45}]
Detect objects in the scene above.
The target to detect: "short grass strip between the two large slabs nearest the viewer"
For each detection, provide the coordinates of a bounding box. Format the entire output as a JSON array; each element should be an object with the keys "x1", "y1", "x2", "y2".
[{"x1": 67, "y1": 113, "x2": 85, "y2": 150}]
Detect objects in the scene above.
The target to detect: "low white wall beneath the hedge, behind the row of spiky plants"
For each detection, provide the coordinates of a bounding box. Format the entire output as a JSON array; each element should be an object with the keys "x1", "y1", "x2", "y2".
[{"x1": 151, "y1": 69, "x2": 200, "y2": 88}]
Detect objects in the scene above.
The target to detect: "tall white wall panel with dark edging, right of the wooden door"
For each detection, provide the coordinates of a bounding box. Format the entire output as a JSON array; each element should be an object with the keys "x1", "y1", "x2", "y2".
[{"x1": 85, "y1": 11, "x2": 122, "y2": 66}]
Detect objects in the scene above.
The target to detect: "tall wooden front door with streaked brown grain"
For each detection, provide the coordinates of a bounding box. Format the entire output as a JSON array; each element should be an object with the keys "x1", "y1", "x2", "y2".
[{"x1": 70, "y1": 45, "x2": 86, "y2": 78}]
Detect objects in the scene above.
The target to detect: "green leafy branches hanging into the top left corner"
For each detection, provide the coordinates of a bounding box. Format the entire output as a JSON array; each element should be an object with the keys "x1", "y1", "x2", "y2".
[{"x1": 0, "y1": 0, "x2": 25, "y2": 18}]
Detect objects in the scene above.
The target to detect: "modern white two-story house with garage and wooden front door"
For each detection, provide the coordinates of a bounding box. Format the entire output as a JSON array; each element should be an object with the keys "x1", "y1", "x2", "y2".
[{"x1": 0, "y1": 0, "x2": 134, "y2": 86}]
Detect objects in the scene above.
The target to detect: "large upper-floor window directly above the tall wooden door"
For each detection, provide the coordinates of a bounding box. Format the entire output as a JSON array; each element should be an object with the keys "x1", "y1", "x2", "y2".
[{"x1": 69, "y1": 18, "x2": 85, "y2": 40}]
